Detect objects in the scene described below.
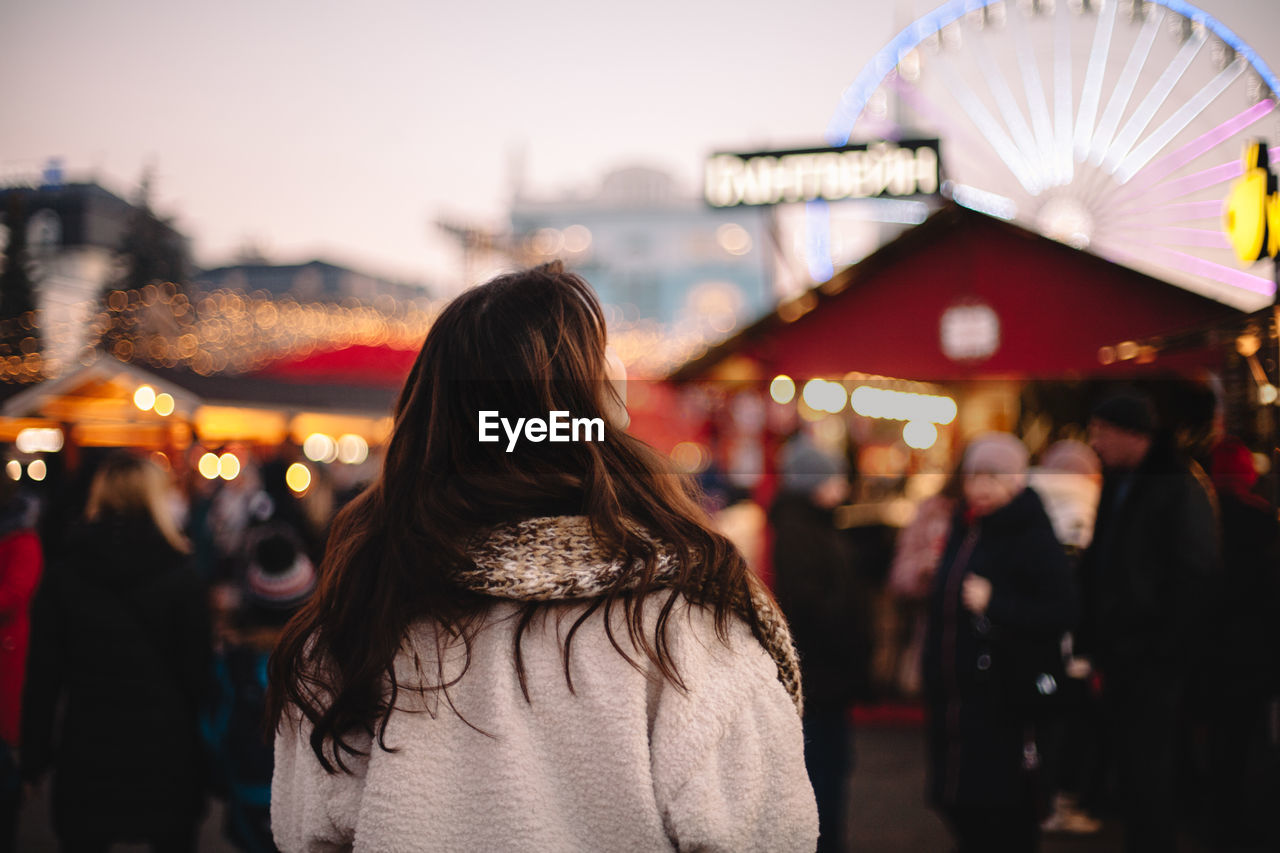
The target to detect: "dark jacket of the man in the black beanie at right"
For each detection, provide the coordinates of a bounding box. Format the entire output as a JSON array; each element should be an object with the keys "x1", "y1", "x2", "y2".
[{"x1": 1076, "y1": 443, "x2": 1220, "y2": 681}]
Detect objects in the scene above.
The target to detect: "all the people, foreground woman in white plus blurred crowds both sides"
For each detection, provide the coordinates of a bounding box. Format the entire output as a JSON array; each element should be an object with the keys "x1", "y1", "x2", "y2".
[{"x1": 0, "y1": 264, "x2": 1280, "y2": 853}]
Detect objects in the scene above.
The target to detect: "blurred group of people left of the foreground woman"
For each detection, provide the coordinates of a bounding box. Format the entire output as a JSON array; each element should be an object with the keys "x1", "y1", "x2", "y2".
[{"x1": 0, "y1": 451, "x2": 340, "y2": 853}]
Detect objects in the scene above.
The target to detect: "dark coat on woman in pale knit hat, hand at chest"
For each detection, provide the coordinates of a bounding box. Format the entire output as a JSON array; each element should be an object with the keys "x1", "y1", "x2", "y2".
[{"x1": 923, "y1": 489, "x2": 1078, "y2": 807}]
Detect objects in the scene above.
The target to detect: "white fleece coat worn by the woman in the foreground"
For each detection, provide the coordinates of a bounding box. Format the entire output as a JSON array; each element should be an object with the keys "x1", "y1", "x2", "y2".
[{"x1": 271, "y1": 594, "x2": 818, "y2": 853}]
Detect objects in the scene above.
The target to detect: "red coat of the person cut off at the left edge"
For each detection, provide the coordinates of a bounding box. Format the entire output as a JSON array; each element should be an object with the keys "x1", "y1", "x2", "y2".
[{"x1": 0, "y1": 507, "x2": 42, "y2": 747}]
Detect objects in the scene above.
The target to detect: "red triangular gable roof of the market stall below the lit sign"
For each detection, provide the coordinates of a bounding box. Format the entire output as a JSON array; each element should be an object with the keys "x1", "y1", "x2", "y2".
[{"x1": 669, "y1": 205, "x2": 1242, "y2": 382}]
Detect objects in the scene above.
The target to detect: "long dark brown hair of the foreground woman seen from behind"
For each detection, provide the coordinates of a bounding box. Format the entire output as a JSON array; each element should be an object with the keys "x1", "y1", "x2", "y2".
[{"x1": 268, "y1": 263, "x2": 759, "y2": 772}]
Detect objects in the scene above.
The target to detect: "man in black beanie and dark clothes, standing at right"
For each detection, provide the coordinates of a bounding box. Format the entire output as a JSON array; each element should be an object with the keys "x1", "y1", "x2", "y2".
[{"x1": 1079, "y1": 393, "x2": 1219, "y2": 850}]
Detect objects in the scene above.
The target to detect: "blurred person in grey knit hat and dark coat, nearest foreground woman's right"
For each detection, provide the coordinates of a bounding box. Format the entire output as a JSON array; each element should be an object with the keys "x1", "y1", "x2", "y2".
[{"x1": 769, "y1": 434, "x2": 867, "y2": 852}]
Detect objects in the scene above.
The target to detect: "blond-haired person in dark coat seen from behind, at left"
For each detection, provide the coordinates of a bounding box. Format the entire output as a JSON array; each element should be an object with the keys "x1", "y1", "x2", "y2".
[{"x1": 20, "y1": 455, "x2": 211, "y2": 850}]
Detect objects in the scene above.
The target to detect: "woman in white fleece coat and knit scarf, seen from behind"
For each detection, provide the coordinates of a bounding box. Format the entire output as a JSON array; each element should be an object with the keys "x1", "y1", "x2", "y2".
[{"x1": 269, "y1": 264, "x2": 817, "y2": 850}]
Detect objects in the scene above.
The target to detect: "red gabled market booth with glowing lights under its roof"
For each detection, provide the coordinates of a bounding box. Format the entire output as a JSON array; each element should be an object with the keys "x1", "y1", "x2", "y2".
[{"x1": 669, "y1": 205, "x2": 1243, "y2": 591}]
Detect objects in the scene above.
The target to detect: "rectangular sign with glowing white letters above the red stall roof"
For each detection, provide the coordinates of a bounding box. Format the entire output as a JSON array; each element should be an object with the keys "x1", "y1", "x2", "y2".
[{"x1": 703, "y1": 140, "x2": 941, "y2": 207}]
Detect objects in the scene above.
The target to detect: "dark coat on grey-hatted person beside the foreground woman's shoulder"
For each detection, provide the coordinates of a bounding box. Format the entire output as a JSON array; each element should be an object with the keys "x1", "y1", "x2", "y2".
[{"x1": 771, "y1": 492, "x2": 869, "y2": 712}]
